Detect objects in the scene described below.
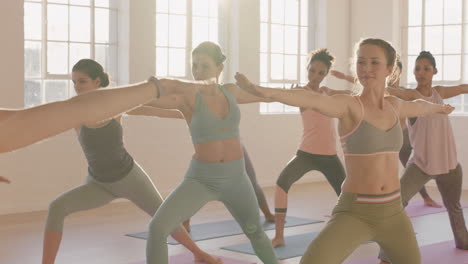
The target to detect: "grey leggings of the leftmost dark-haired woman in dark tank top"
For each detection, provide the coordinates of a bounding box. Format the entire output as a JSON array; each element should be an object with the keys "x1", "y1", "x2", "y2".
[{"x1": 46, "y1": 163, "x2": 163, "y2": 232}]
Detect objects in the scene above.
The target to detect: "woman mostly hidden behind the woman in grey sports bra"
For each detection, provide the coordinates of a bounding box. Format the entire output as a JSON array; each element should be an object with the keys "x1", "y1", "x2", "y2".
[{"x1": 330, "y1": 57, "x2": 442, "y2": 208}]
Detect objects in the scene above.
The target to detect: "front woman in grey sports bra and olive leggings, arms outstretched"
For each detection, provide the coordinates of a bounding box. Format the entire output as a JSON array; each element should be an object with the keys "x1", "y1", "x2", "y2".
[{"x1": 236, "y1": 39, "x2": 453, "y2": 264}]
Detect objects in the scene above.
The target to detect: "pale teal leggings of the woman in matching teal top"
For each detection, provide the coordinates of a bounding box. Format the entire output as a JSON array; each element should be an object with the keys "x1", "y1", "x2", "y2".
[{"x1": 146, "y1": 159, "x2": 278, "y2": 264}]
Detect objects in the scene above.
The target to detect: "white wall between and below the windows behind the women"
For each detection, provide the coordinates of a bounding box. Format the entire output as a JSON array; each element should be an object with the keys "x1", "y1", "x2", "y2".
[{"x1": 0, "y1": 0, "x2": 468, "y2": 214}]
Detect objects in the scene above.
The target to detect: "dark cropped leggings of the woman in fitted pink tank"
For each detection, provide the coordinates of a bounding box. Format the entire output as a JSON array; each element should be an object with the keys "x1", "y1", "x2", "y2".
[{"x1": 276, "y1": 150, "x2": 346, "y2": 195}]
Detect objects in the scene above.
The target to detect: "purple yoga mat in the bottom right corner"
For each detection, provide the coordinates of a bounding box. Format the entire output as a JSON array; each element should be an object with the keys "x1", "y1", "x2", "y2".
[{"x1": 344, "y1": 240, "x2": 468, "y2": 264}]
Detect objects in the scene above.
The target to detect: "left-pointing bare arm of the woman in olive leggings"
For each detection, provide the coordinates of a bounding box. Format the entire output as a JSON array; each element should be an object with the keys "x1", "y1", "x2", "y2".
[{"x1": 236, "y1": 73, "x2": 352, "y2": 118}]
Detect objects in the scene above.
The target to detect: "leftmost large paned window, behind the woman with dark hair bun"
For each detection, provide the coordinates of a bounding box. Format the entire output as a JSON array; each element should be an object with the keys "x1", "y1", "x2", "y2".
[{"x1": 24, "y1": 0, "x2": 118, "y2": 106}]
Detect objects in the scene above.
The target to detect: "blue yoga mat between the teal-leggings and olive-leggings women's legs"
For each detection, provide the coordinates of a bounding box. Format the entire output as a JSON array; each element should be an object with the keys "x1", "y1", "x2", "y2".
[{"x1": 222, "y1": 232, "x2": 372, "y2": 260}]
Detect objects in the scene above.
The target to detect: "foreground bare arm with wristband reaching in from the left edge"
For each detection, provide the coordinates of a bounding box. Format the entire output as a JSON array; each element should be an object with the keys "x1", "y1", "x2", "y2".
[{"x1": 0, "y1": 79, "x2": 157, "y2": 153}]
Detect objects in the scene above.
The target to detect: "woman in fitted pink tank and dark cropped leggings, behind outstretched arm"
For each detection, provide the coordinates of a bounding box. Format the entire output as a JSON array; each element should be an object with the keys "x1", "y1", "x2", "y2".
[{"x1": 272, "y1": 49, "x2": 349, "y2": 247}]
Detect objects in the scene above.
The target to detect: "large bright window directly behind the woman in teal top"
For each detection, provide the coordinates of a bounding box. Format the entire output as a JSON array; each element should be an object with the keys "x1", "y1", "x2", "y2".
[{"x1": 156, "y1": 0, "x2": 223, "y2": 79}]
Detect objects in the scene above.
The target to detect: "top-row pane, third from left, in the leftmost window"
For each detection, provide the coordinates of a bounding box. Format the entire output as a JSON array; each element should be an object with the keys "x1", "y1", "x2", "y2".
[{"x1": 70, "y1": 6, "x2": 91, "y2": 42}]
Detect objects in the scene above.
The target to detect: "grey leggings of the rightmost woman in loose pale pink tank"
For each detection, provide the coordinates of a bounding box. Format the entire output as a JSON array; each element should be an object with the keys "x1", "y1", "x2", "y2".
[{"x1": 380, "y1": 163, "x2": 468, "y2": 264}]
